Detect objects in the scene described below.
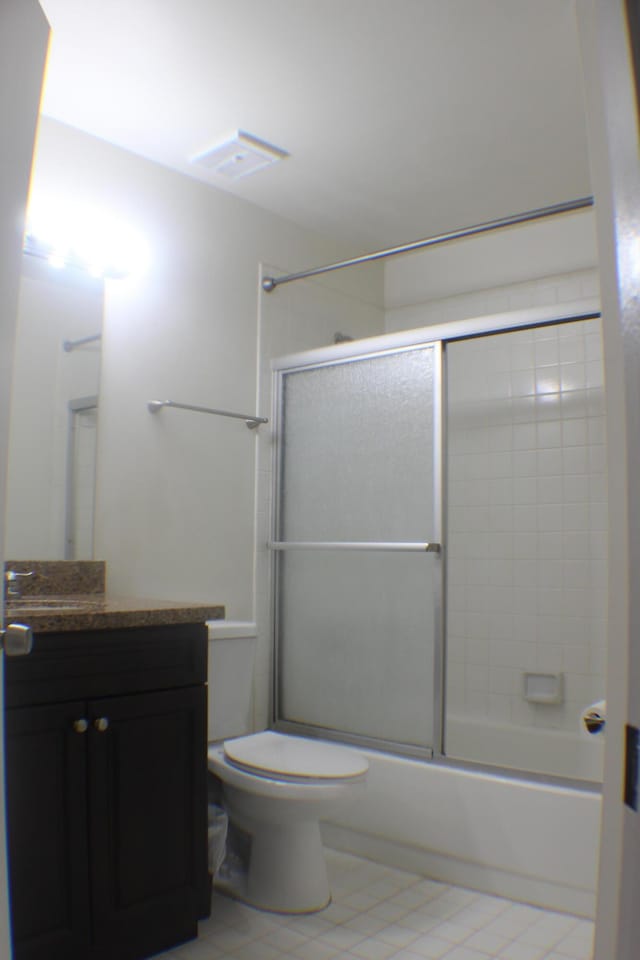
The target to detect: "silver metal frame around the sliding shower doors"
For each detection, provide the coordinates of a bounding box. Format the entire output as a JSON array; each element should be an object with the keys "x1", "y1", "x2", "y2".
[{"x1": 269, "y1": 297, "x2": 601, "y2": 764}]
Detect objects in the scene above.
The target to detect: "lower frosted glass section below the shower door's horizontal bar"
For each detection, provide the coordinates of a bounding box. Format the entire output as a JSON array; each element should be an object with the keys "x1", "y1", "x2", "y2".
[{"x1": 278, "y1": 550, "x2": 439, "y2": 748}]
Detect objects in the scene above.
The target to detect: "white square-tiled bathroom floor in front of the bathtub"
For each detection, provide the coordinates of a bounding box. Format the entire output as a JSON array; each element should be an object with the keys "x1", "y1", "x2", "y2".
[{"x1": 160, "y1": 850, "x2": 593, "y2": 960}]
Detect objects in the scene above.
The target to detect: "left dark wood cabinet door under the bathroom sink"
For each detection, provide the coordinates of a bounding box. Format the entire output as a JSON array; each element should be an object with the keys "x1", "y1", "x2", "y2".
[{"x1": 5, "y1": 703, "x2": 89, "y2": 960}]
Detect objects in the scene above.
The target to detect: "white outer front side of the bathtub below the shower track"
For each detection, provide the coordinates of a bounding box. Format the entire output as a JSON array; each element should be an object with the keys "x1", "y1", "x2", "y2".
[{"x1": 323, "y1": 751, "x2": 601, "y2": 917}]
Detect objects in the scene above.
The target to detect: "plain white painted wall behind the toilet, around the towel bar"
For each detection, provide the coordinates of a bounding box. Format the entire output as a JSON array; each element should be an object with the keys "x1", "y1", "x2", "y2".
[{"x1": 26, "y1": 120, "x2": 382, "y2": 619}]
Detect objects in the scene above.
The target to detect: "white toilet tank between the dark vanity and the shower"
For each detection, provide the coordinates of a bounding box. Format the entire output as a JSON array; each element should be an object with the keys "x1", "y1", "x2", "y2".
[{"x1": 207, "y1": 620, "x2": 256, "y2": 741}]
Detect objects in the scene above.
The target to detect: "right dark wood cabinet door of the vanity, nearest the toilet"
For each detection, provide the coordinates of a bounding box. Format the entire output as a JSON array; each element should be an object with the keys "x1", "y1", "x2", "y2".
[{"x1": 89, "y1": 686, "x2": 207, "y2": 960}]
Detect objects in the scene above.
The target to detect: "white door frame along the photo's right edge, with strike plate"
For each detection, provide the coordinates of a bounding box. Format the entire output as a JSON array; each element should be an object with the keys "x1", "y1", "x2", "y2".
[{"x1": 576, "y1": 0, "x2": 640, "y2": 960}]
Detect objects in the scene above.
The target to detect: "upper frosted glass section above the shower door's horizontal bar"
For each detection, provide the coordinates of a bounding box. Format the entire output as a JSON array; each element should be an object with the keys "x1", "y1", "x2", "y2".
[{"x1": 280, "y1": 346, "x2": 434, "y2": 541}]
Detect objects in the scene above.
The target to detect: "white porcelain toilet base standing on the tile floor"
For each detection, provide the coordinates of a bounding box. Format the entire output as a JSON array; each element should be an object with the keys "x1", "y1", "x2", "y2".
[{"x1": 214, "y1": 820, "x2": 331, "y2": 913}]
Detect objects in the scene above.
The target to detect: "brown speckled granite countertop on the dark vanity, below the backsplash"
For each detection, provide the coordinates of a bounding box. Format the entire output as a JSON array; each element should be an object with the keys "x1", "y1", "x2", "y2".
[{"x1": 5, "y1": 593, "x2": 225, "y2": 633}]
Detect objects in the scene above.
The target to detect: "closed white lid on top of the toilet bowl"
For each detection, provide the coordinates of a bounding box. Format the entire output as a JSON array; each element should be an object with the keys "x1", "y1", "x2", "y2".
[{"x1": 224, "y1": 730, "x2": 369, "y2": 780}]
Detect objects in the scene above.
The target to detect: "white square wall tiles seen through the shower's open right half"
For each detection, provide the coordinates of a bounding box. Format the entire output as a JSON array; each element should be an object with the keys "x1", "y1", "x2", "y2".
[{"x1": 448, "y1": 318, "x2": 607, "y2": 777}]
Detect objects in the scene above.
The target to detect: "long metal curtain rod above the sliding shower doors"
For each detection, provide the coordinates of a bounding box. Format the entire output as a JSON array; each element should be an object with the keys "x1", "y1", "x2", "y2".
[{"x1": 262, "y1": 197, "x2": 593, "y2": 293}]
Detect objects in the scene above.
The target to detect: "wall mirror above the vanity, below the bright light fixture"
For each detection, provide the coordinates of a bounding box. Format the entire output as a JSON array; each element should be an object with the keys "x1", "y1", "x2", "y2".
[{"x1": 5, "y1": 254, "x2": 103, "y2": 560}]
